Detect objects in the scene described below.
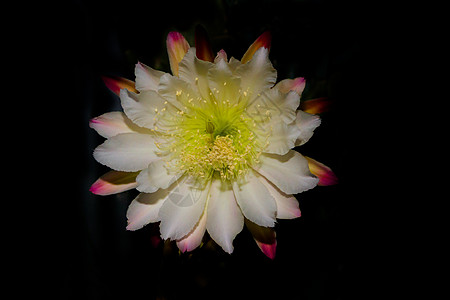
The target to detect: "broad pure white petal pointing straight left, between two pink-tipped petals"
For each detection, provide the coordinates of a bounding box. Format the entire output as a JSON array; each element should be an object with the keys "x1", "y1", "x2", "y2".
[{"x1": 94, "y1": 133, "x2": 158, "y2": 172}]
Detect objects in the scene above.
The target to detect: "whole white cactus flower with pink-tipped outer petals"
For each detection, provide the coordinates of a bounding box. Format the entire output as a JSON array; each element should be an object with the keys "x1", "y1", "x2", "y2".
[{"x1": 90, "y1": 32, "x2": 334, "y2": 257}]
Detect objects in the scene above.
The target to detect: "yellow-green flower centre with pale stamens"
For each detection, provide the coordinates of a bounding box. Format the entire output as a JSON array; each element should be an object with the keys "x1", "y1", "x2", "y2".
[{"x1": 157, "y1": 85, "x2": 267, "y2": 182}]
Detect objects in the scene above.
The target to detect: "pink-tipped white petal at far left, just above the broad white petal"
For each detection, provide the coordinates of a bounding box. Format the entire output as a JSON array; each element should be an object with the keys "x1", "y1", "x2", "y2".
[{"x1": 89, "y1": 111, "x2": 151, "y2": 138}]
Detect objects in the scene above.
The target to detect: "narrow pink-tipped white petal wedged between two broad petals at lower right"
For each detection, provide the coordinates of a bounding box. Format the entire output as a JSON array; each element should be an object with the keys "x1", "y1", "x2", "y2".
[{"x1": 260, "y1": 177, "x2": 301, "y2": 219}]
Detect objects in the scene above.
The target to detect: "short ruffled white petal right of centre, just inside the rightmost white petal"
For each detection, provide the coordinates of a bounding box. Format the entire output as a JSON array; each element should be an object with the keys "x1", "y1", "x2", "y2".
[{"x1": 264, "y1": 122, "x2": 300, "y2": 155}]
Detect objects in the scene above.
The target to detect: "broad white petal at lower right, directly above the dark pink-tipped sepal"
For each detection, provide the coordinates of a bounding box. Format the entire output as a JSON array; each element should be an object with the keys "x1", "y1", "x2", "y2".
[{"x1": 233, "y1": 172, "x2": 277, "y2": 227}]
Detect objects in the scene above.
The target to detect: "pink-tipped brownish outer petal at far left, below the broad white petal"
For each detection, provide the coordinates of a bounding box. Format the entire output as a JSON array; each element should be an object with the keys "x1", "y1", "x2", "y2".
[{"x1": 89, "y1": 171, "x2": 138, "y2": 196}]
